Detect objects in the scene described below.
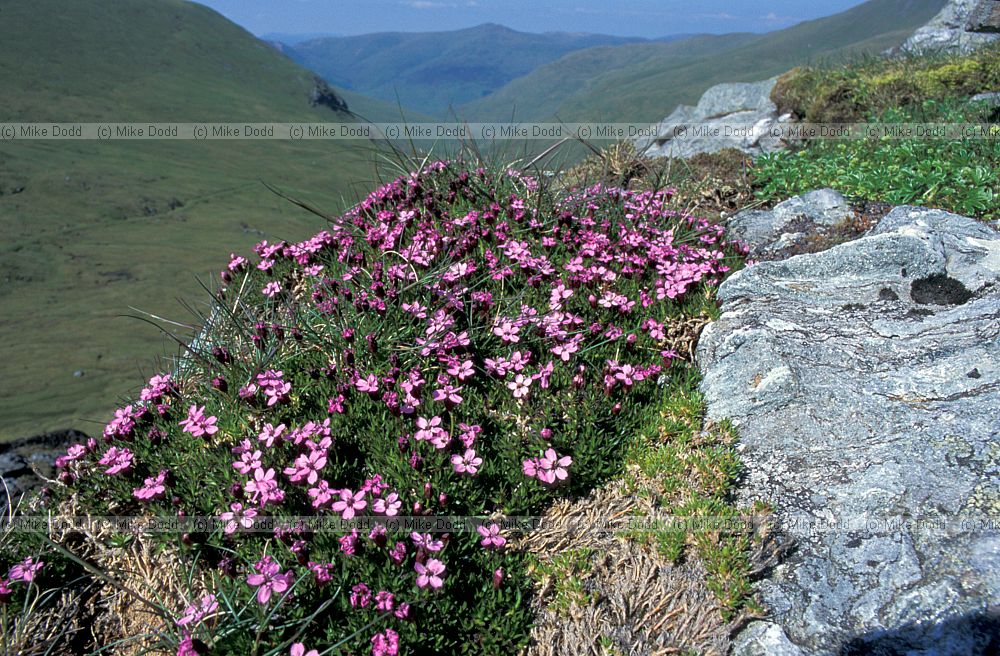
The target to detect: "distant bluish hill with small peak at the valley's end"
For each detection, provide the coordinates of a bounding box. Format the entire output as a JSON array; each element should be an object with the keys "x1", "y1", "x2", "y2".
[{"x1": 284, "y1": 25, "x2": 656, "y2": 114}]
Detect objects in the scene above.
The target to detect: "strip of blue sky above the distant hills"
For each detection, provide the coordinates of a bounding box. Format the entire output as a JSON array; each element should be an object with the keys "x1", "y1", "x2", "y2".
[{"x1": 191, "y1": 0, "x2": 863, "y2": 37}]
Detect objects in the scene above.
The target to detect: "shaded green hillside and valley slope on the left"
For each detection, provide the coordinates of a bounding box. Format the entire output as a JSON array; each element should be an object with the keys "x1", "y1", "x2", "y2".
[{"x1": 0, "y1": 0, "x2": 398, "y2": 439}]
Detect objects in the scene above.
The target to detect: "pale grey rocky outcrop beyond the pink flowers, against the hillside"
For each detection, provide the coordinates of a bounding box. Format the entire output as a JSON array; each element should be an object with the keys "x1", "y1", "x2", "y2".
[{"x1": 635, "y1": 77, "x2": 792, "y2": 157}]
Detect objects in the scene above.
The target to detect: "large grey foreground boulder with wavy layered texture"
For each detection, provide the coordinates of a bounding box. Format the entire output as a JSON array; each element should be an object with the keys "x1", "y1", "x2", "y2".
[{"x1": 698, "y1": 207, "x2": 1000, "y2": 656}]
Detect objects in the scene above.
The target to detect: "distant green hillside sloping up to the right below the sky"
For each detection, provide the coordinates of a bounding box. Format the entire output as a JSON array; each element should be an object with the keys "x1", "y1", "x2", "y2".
[{"x1": 458, "y1": 0, "x2": 945, "y2": 122}]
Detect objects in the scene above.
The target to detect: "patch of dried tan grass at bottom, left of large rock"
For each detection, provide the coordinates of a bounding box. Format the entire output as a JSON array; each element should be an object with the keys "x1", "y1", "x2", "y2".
[{"x1": 513, "y1": 472, "x2": 731, "y2": 656}]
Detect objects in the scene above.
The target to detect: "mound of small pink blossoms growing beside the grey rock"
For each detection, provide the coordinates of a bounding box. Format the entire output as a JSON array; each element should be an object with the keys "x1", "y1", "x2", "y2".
[{"x1": 50, "y1": 162, "x2": 744, "y2": 656}]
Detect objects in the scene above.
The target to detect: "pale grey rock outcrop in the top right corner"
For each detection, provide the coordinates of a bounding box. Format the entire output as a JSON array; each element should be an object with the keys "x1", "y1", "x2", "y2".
[{"x1": 901, "y1": 0, "x2": 1000, "y2": 52}]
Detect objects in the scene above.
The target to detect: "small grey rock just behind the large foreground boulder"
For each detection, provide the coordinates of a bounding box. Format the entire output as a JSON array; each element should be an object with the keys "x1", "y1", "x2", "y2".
[{"x1": 726, "y1": 189, "x2": 854, "y2": 259}]
